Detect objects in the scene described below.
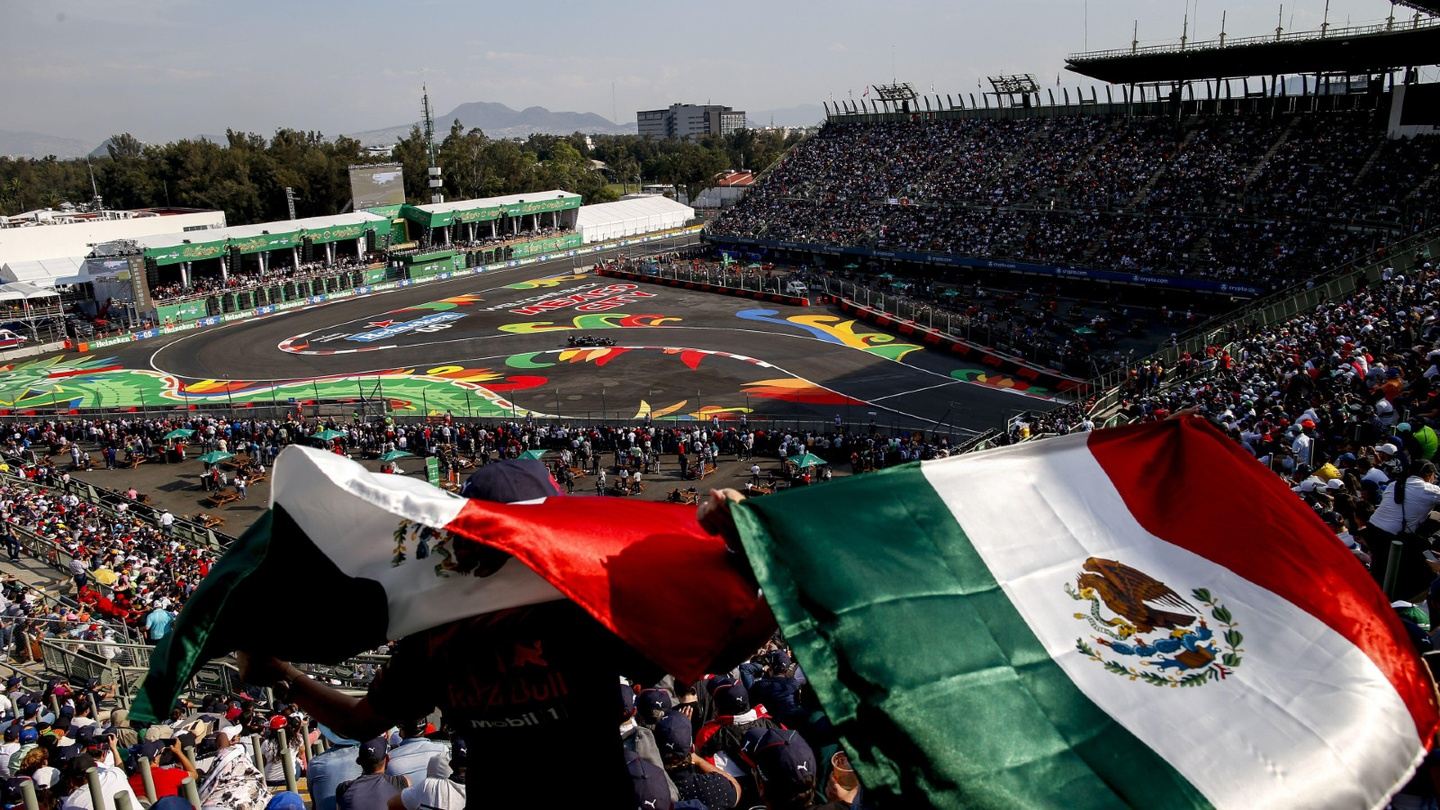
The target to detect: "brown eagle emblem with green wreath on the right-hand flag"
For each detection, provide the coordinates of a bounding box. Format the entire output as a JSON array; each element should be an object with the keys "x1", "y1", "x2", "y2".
[{"x1": 1066, "y1": 556, "x2": 1244, "y2": 687}]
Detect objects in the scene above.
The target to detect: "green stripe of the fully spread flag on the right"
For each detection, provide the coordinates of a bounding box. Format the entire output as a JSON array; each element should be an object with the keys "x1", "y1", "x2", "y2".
[{"x1": 736, "y1": 464, "x2": 1224, "y2": 809}]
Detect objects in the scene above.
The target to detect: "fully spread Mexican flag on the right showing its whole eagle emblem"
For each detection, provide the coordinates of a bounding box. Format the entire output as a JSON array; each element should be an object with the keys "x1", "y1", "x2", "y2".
[{"x1": 736, "y1": 418, "x2": 1437, "y2": 809}]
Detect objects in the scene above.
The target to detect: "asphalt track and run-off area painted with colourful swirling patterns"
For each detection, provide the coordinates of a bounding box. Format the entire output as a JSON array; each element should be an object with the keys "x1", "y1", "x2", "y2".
[{"x1": 0, "y1": 268, "x2": 1053, "y2": 430}]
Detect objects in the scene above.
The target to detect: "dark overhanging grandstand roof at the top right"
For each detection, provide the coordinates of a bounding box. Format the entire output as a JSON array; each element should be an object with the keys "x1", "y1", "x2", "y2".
[{"x1": 1066, "y1": 16, "x2": 1440, "y2": 85}]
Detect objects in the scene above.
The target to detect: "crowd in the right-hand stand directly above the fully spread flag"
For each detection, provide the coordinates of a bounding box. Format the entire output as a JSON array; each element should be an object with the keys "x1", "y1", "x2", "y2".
[{"x1": 1123, "y1": 262, "x2": 1440, "y2": 605}]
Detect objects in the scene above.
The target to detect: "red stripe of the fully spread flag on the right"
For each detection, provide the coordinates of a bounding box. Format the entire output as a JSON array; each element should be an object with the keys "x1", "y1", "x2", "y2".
[{"x1": 1089, "y1": 417, "x2": 1440, "y2": 748}]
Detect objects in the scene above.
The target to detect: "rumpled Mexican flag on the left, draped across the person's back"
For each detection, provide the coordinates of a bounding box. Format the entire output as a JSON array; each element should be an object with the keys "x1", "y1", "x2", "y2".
[{"x1": 131, "y1": 447, "x2": 775, "y2": 722}]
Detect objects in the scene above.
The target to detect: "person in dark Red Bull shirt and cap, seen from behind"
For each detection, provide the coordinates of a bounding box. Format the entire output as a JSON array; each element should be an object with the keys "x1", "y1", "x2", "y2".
[{"x1": 239, "y1": 460, "x2": 731, "y2": 807}]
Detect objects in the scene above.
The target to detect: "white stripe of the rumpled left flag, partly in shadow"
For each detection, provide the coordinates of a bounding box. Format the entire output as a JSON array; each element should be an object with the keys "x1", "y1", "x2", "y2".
[{"x1": 271, "y1": 447, "x2": 564, "y2": 638}]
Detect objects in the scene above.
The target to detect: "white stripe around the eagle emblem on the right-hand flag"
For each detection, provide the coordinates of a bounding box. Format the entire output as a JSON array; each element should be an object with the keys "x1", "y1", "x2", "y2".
[{"x1": 922, "y1": 434, "x2": 1424, "y2": 809}]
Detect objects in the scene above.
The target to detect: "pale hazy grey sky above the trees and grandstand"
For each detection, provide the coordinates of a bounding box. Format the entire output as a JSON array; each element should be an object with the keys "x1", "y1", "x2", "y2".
[{"x1": 0, "y1": 0, "x2": 1405, "y2": 141}]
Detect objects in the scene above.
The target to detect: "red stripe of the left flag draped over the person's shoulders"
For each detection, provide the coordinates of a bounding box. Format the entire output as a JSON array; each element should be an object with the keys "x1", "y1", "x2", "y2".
[{"x1": 445, "y1": 497, "x2": 775, "y2": 680}]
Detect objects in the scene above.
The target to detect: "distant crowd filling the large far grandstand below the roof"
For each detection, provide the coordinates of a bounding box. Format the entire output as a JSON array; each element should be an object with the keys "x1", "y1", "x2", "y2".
[{"x1": 711, "y1": 112, "x2": 1440, "y2": 287}]
